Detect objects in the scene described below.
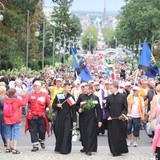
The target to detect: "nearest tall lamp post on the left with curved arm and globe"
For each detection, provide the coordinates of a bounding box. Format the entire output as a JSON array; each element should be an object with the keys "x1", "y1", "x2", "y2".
[{"x1": 26, "y1": 10, "x2": 40, "y2": 68}]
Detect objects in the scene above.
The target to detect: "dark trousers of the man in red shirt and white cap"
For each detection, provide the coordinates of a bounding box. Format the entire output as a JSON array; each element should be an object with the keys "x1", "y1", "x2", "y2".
[{"x1": 29, "y1": 116, "x2": 46, "y2": 144}]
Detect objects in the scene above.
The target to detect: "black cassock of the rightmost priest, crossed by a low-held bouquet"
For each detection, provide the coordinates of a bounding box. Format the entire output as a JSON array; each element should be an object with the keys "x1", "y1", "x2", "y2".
[{"x1": 106, "y1": 93, "x2": 128, "y2": 155}]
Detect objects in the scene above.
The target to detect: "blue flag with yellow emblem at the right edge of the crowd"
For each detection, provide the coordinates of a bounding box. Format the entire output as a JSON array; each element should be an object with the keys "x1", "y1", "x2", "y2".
[{"x1": 138, "y1": 41, "x2": 159, "y2": 77}]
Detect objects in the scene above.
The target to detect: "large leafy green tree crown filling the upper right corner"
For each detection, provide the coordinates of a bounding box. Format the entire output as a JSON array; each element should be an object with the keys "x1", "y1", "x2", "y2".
[{"x1": 116, "y1": 0, "x2": 160, "y2": 45}]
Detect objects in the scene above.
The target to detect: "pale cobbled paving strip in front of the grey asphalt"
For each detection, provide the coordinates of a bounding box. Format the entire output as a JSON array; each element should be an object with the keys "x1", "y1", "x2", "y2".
[{"x1": 0, "y1": 146, "x2": 153, "y2": 160}]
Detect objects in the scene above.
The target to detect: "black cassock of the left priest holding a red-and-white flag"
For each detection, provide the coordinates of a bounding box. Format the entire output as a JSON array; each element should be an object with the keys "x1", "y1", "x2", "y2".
[{"x1": 52, "y1": 93, "x2": 77, "y2": 154}]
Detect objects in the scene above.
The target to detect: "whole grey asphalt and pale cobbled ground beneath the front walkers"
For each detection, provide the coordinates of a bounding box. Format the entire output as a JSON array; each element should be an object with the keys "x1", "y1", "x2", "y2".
[{"x1": 0, "y1": 120, "x2": 153, "y2": 160}]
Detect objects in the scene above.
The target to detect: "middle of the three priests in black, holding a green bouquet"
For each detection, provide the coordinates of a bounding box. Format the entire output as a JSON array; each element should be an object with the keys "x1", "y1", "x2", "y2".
[{"x1": 77, "y1": 85, "x2": 102, "y2": 155}]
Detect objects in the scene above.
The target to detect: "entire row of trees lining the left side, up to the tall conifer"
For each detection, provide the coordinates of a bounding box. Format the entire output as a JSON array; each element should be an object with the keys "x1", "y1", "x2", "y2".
[{"x1": 0, "y1": 0, "x2": 82, "y2": 70}]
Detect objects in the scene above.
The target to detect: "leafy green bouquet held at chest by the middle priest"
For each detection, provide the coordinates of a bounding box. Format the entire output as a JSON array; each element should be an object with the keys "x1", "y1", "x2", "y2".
[{"x1": 80, "y1": 98, "x2": 98, "y2": 112}]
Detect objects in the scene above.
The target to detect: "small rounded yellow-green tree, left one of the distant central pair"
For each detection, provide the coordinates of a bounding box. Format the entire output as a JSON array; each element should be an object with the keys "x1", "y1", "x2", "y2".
[{"x1": 81, "y1": 27, "x2": 98, "y2": 52}]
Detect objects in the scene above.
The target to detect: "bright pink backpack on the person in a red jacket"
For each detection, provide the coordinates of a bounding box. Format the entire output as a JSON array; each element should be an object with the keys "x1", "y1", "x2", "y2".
[{"x1": 3, "y1": 103, "x2": 13, "y2": 117}]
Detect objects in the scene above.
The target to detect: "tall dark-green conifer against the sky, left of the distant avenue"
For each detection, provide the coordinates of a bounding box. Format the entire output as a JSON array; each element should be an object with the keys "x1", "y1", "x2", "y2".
[{"x1": 45, "y1": 0, "x2": 82, "y2": 64}]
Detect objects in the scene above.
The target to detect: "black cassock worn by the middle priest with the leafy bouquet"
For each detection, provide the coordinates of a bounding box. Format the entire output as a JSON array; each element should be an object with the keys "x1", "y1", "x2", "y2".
[{"x1": 77, "y1": 94, "x2": 102, "y2": 152}]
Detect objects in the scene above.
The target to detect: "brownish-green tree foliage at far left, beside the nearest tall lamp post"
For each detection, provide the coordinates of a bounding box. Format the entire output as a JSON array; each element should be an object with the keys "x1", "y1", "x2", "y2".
[{"x1": 0, "y1": 0, "x2": 42, "y2": 69}]
